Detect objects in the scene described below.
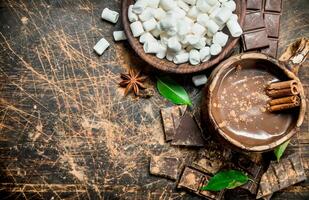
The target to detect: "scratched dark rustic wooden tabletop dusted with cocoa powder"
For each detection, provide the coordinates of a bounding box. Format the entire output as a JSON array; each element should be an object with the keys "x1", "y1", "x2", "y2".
[{"x1": 0, "y1": 0, "x2": 309, "y2": 199}]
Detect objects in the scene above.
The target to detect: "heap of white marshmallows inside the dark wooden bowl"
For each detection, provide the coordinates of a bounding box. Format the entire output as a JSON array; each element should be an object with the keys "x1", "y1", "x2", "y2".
[{"x1": 128, "y1": 0, "x2": 243, "y2": 65}]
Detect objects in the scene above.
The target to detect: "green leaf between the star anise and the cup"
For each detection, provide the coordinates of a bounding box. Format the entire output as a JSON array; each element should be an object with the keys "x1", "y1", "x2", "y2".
[{"x1": 157, "y1": 76, "x2": 192, "y2": 105}]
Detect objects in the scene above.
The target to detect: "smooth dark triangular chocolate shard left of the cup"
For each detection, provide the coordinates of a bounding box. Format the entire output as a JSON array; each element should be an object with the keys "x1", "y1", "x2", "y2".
[{"x1": 171, "y1": 112, "x2": 205, "y2": 147}]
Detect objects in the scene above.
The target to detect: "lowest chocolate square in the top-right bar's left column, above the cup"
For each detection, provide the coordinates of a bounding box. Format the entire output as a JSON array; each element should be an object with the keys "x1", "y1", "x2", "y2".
[{"x1": 242, "y1": 29, "x2": 269, "y2": 51}]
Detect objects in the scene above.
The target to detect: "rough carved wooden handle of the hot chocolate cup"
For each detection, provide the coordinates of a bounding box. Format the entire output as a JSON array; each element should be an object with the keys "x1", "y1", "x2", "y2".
[{"x1": 279, "y1": 38, "x2": 309, "y2": 76}]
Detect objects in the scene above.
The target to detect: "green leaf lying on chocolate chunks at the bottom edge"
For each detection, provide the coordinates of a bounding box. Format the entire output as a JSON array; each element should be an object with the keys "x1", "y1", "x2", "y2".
[{"x1": 201, "y1": 170, "x2": 249, "y2": 191}]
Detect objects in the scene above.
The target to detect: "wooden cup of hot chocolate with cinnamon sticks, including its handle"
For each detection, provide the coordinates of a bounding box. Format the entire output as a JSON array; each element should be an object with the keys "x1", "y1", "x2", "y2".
[{"x1": 202, "y1": 40, "x2": 309, "y2": 151}]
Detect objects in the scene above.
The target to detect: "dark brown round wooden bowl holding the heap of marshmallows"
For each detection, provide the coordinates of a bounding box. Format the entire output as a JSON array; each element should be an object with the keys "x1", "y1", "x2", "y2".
[{"x1": 122, "y1": 0, "x2": 246, "y2": 74}]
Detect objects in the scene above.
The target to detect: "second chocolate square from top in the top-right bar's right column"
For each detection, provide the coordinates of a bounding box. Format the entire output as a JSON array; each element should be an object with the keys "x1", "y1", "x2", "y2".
[{"x1": 264, "y1": 13, "x2": 280, "y2": 38}]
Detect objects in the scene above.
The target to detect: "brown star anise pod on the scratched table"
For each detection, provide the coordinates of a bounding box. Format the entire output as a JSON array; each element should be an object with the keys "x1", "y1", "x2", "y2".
[{"x1": 119, "y1": 69, "x2": 147, "y2": 96}]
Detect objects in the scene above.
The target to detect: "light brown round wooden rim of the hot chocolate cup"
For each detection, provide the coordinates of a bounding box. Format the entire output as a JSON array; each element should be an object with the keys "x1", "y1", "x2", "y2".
[{"x1": 204, "y1": 52, "x2": 306, "y2": 152}]
